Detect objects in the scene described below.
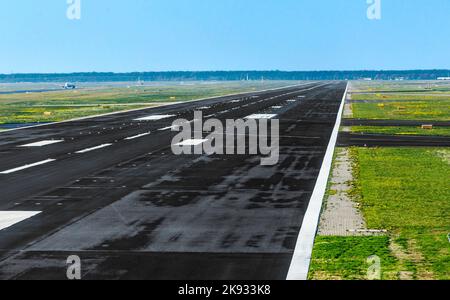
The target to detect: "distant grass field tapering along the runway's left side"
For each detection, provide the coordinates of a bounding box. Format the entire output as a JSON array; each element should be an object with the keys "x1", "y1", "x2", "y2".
[{"x1": 0, "y1": 81, "x2": 297, "y2": 124}]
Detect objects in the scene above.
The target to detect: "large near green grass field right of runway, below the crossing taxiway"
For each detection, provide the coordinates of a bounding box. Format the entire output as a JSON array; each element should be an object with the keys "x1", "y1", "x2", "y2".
[{"x1": 310, "y1": 148, "x2": 450, "y2": 280}]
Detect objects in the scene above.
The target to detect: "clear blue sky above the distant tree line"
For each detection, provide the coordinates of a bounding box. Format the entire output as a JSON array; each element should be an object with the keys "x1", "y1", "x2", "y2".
[{"x1": 0, "y1": 0, "x2": 450, "y2": 73}]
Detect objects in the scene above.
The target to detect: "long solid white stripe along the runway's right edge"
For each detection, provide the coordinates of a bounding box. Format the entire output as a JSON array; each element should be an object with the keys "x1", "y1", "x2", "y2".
[{"x1": 287, "y1": 83, "x2": 348, "y2": 280}]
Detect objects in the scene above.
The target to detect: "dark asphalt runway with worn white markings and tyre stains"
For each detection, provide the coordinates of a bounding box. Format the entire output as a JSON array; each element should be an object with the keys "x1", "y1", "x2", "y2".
[{"x1": 0, "y1": 82, "x2": 346, "y2": 280}]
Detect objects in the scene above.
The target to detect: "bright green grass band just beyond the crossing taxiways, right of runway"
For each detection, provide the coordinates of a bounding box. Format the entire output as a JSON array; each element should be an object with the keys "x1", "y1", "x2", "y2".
[{"x1": 352, "y1": 100, "x2": 450, "y2": 121}]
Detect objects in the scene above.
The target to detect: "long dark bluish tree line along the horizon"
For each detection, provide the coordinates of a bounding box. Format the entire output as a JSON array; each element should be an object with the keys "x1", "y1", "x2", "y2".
[{"x1": 0, "y1": 70, "x2": 450, "y2": 83}]
